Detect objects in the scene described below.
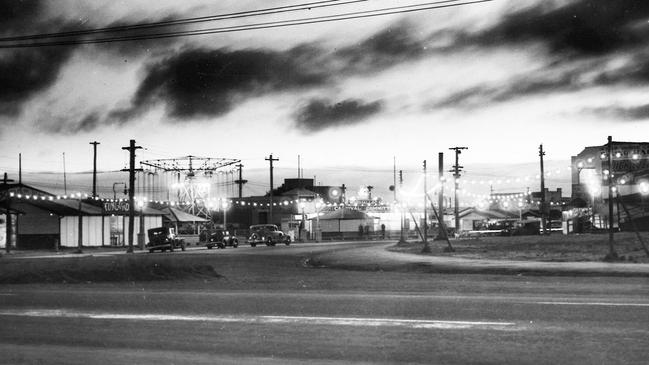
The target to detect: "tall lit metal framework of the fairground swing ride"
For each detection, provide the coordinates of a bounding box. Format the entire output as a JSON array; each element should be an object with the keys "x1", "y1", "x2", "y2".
[{"x1": 141, "y1": 155, "x2": 241, "y2": 218}]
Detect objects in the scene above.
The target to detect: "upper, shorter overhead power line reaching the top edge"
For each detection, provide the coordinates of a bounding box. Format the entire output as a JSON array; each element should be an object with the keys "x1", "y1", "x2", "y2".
[{"x1": 0, "y1": 0, "x2": 369, "y2": 42}]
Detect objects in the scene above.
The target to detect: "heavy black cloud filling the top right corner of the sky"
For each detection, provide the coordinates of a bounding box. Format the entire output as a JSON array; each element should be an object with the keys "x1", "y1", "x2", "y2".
[{"x1": 468, "y1": 0, "x2": 649, "y2": 55}]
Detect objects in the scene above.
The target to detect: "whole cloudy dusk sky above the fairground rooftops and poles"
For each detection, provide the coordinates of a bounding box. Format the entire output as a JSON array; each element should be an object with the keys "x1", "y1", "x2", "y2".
[{"x1": 0, "y1": 0, "x2": 649, "y2": 198}]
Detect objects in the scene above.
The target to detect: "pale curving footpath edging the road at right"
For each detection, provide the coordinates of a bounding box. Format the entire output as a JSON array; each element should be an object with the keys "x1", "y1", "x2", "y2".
[{"x1": 311, "y1": 243, "x2": 649, "y2": 277}]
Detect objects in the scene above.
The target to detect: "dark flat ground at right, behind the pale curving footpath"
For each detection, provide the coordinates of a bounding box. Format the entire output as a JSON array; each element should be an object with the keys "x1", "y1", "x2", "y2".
[{"x1": 391, "y1": 232, "x2": 649, "y2": 263}]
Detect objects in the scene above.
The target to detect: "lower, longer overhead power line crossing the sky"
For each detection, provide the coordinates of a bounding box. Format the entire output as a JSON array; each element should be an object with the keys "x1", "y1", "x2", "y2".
[{"x1": 0, "y1": 0, "x2": 495, "y2": 49}]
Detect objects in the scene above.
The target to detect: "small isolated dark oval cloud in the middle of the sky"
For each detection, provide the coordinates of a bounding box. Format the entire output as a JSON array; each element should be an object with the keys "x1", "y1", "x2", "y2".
[{"x1": 295, "y1": 99, "x2": 383, "y2": 132}]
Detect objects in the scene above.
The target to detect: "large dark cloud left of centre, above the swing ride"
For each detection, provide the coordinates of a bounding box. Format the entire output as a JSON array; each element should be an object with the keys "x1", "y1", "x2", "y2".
[{"x1": 110, "y1": 49, "x2": 329, "y2": 120}]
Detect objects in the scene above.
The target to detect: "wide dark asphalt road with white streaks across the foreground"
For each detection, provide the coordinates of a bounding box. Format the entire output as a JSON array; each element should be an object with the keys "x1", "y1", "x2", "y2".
[{"x1": 0, "y1": 240, "x2": 649, "y2": 364}]
